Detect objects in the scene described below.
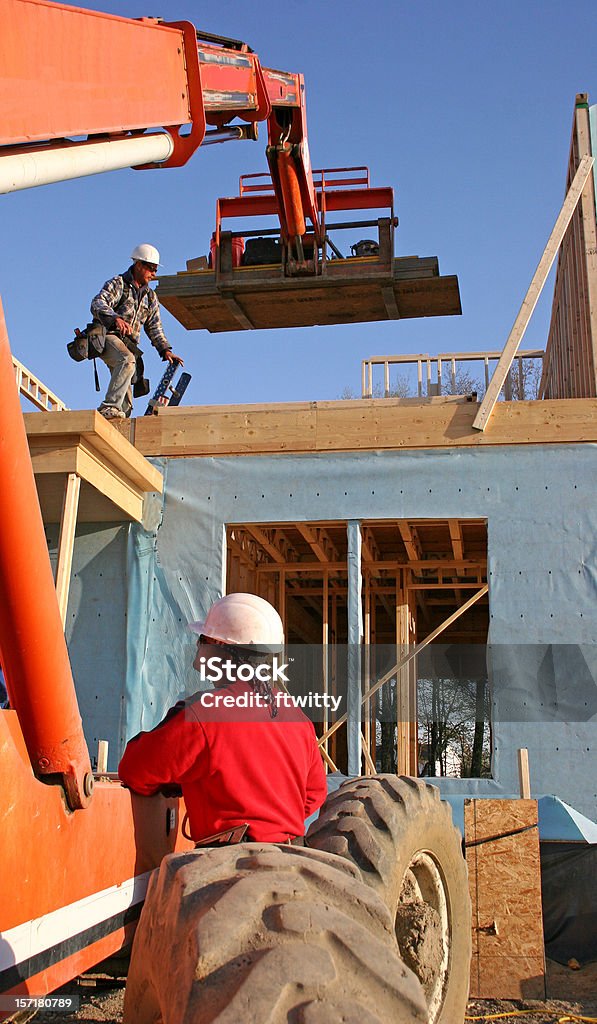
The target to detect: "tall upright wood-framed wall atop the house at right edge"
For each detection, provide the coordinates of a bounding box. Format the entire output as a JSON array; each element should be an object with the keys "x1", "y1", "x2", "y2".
[{"x1": 541, "y1": 93, "x2": 597, "y2": 398}]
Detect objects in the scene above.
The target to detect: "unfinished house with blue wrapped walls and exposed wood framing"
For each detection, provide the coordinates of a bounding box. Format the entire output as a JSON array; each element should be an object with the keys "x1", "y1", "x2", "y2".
[{"x1": 17, "y1": 90, "x2": 597, "y2": 818}]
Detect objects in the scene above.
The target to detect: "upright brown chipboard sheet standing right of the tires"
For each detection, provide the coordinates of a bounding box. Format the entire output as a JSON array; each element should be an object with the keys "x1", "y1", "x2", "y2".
[{"x1": 465, "y1": 800, "x2": 545, "y2": 998}]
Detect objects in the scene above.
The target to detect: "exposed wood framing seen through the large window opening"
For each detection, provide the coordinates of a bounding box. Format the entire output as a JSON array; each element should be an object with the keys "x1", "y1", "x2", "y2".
[{"x1": 226, "y1": 519, "x2": 488, "y2": 775}]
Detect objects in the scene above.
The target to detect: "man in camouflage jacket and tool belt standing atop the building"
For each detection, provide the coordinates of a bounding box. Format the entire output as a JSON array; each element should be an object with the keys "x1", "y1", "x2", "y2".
[{"x1": 91, "y1": 243, "x2": 182, "y2": 420}]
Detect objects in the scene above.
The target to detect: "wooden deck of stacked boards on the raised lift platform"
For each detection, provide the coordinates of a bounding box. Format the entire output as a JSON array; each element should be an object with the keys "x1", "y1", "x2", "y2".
[{"x1": 157, "y1": 256, "x2": 462, "y2": 334}]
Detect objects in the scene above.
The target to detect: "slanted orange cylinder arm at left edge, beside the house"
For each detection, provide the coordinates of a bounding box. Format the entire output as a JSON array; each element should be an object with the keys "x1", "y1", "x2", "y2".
[{"x1": 0, "y1": 302, "x2": 93, "y2": 810}]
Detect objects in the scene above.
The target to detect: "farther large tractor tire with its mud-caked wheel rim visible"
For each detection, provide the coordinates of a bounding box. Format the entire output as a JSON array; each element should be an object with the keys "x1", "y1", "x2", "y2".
[{"x1": 307, "y1": 775, "x2": 471, "y2": 1024}]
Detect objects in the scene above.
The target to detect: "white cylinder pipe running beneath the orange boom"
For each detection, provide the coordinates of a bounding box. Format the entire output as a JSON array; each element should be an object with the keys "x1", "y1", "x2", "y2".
[{"x1": 0, "y1": 132, "x2": 174, "y2": 194}]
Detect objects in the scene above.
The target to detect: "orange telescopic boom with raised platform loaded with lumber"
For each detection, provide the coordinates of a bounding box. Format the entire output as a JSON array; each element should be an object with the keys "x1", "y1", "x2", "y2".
[{"x1": 0, "y1": 0, "x2": 461, "y2": 331}]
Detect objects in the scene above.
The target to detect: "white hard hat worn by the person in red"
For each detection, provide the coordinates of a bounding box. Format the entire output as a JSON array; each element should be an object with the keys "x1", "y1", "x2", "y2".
[{"x1": 188, "y1": 594, "x2": 284, "y2": 654}]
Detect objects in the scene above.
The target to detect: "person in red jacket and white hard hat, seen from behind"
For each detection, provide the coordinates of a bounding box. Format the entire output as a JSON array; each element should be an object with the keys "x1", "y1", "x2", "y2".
[{"x1": 119, "y1": 594, "x2": 327, "y2": 845}]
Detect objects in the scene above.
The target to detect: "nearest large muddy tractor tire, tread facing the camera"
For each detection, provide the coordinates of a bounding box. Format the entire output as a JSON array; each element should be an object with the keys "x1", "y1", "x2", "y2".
[{"x1": 124, "y1": 843, "x2": 427, "y2": 1024}]
